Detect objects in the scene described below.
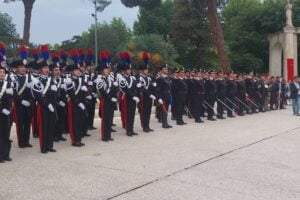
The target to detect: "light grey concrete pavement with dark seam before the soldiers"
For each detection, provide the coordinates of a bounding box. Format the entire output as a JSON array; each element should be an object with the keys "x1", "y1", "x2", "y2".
[{"x1": 0, "y1": 108, "x2": 300, "y2": 200}]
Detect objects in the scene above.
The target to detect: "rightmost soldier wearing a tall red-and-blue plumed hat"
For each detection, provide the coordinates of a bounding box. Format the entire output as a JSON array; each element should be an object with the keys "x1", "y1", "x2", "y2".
[{"x1": 138, "y1": 52, "x2": 156, "y2": 132}]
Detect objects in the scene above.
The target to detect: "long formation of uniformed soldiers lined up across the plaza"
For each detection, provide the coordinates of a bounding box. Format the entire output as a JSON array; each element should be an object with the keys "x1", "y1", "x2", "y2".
[{"x1": 0, "y1": 43, "x2": 290, "y2": 163}]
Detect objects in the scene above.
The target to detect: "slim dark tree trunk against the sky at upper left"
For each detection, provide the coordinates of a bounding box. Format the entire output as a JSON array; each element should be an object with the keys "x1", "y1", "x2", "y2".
[{"x1": 22, "y1": 0, "x2": 35, "y2": 45}]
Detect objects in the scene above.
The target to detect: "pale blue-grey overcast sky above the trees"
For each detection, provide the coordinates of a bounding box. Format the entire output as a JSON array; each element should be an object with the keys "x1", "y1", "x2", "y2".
[{"x1": 0, "y1": 0, "x2": 138, "y2": 44}]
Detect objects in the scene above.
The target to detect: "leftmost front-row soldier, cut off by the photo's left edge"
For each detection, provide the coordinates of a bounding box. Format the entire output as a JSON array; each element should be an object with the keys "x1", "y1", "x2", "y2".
[{"x1": 0, "y1": 65, "x2": 13, "y2": 163}]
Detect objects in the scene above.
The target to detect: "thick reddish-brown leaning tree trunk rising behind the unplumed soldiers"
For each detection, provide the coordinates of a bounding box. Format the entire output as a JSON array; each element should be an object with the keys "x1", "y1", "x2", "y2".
[{"x1": 207, "y1": 0, "x2": 231, "y2": 73}]
